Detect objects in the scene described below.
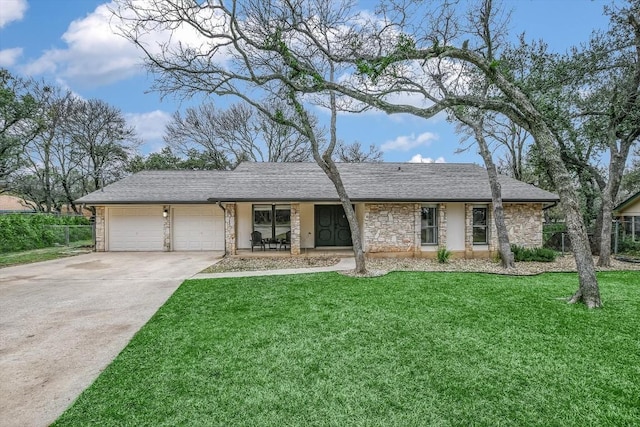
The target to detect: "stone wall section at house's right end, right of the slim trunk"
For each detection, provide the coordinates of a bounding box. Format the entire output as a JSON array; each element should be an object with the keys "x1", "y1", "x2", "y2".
[{"x1": 504, "y1": 203, "x2": 542, "y2": 248}]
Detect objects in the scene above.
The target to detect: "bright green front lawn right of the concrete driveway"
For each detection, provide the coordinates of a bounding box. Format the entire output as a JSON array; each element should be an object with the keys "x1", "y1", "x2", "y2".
[{"x1": 55, "y1": 272, "x2": 640, "y2": 426}]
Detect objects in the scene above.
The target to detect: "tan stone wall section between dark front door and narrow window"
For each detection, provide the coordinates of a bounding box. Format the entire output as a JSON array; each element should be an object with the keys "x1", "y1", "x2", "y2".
[{"x1": 363, "y1": 203, "x2": 420, "y2": 255}]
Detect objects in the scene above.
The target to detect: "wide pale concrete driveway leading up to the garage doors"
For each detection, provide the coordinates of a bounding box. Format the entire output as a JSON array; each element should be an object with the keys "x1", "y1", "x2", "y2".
[{"x1": 0, "y1": 252, "x2": 223, "y2": 427}]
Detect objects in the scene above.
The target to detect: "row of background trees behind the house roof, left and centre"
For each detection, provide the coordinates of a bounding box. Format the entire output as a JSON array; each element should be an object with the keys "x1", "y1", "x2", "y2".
[{"x1": 0, "y1": 70, "x2": 382, "y2": 213}]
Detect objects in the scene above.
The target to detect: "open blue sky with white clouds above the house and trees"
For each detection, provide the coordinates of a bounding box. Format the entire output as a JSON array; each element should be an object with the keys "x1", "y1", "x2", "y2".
[{"x1": 0, "y1": 0, "x2": 609, "y2": 163}]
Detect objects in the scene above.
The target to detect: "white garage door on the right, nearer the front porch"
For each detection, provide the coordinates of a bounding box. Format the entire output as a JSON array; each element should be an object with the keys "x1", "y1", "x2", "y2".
[{"x1": 173, "y1": 206, "x2": 224, "y2": 251}]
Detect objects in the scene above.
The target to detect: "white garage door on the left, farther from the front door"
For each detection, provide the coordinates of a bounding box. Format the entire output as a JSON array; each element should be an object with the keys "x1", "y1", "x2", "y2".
[{"x1": 109, "y1": 206, "x2": 164, "y2": 251}]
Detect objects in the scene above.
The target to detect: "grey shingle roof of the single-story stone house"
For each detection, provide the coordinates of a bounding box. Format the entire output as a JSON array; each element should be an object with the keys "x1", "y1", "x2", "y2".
[{"x1": 72, "y1": 162, "x2": 558, "y2": 205}]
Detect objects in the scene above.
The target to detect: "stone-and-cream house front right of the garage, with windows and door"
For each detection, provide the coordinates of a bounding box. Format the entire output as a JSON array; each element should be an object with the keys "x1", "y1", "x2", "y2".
[{"x1": 225, "y1": 202, "x2": 542, "y2": 259}]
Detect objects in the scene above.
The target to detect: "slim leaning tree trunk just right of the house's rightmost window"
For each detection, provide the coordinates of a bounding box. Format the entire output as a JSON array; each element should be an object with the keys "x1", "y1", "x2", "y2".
[{"x1": 474, "y1": 130, "x2": 515, "y2": 268}]
